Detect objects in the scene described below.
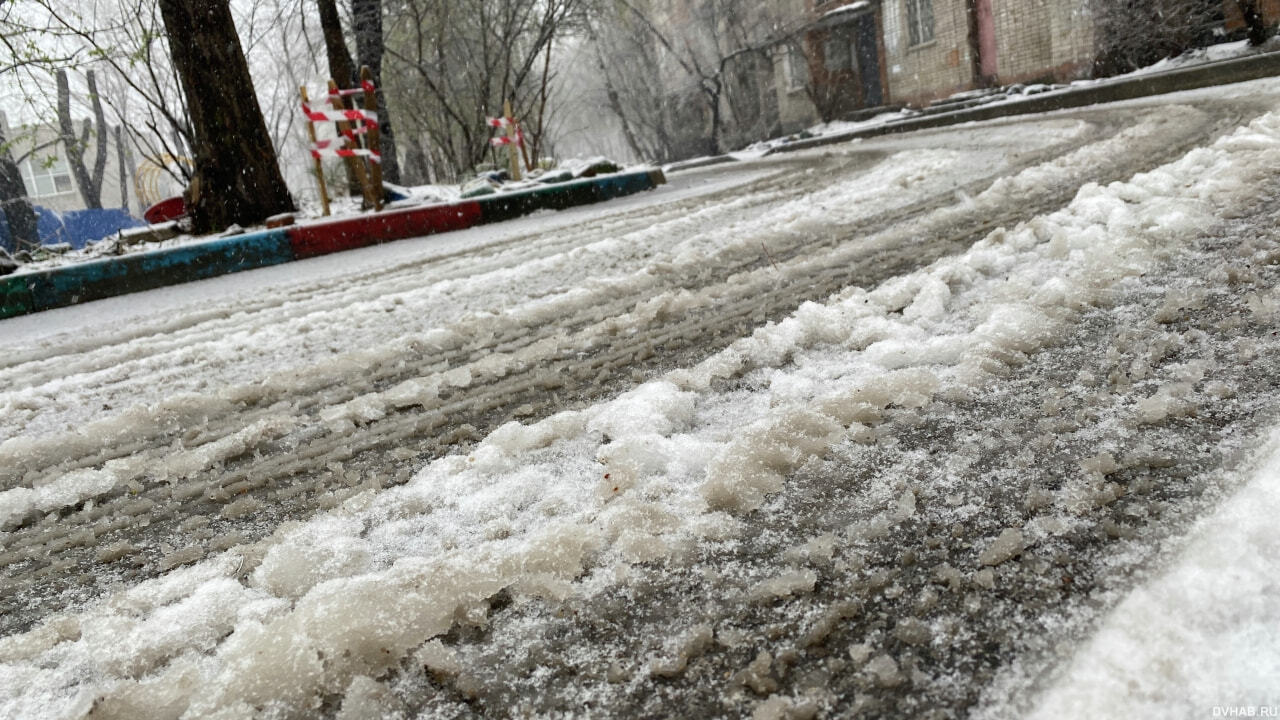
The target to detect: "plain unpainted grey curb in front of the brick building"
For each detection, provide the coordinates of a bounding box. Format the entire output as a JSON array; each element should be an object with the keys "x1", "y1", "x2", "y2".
[{"x1": 765, "y1": 53, "x2": 1280, "y2": 155}]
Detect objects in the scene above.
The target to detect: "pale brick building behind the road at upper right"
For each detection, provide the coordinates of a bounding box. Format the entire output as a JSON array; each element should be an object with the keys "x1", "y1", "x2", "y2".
[{"x1": 774, "y1": 0, "x2": 1264, "y2": 132}]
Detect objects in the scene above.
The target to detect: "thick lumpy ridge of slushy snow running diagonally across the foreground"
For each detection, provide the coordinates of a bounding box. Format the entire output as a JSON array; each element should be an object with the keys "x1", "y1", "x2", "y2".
[{"x1": 0, "y1": 114, "x2": 1280, "y2": 719}]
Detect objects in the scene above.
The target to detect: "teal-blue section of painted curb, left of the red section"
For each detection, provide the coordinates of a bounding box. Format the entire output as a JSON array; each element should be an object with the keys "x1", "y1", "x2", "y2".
[{"x1": 28, "y1": 229, "x2": 293, "y2": 310}]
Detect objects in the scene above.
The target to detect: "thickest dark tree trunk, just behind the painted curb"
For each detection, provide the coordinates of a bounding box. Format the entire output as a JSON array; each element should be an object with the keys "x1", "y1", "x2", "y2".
[{"x1": 160, "y1": 0, "x2": 293, "y2": 232}]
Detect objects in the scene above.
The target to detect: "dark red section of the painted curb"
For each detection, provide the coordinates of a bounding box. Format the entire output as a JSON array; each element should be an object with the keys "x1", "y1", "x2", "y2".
[{"x1": 287, "y1": 202, "x2": 480, "y2": 260}]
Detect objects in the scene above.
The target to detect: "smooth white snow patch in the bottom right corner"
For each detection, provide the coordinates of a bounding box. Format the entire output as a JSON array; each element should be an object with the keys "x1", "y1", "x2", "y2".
[{"x1": 1023, "y1": 422, "x2": 1280, "y2": 720}]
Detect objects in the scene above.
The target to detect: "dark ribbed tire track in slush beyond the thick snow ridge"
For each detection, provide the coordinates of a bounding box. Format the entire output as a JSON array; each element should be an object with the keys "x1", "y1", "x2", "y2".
[{"x1": 0, "y1": 98, "x2": 1264, "y2": 630}]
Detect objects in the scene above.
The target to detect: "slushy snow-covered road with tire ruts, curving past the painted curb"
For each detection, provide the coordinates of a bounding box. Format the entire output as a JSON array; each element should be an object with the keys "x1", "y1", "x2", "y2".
[{"x1": 0, "y1": 82, "x2": 1280, "y2": 717}]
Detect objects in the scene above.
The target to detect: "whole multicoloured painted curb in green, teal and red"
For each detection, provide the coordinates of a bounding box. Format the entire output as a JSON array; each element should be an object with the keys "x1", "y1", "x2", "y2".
[{"x1": 0, "y1": 170, "x2": 667, "y2": 319}]
